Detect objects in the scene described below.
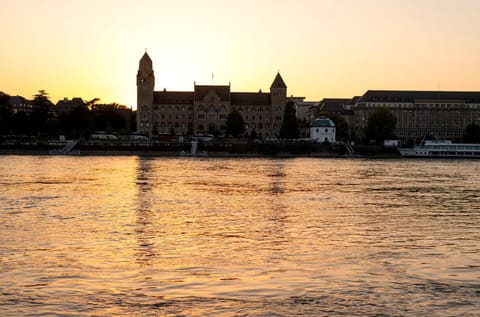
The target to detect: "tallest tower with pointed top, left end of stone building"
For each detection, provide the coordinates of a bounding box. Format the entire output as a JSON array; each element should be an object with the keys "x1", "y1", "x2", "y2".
[{"x1": 137, "y1": 52, "x2": 155, "y2": 137}]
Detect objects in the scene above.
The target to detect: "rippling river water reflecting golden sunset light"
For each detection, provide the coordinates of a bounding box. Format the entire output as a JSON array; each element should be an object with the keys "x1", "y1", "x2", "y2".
[{"x1": 0, "y1": 156, "x2": 480, "y2": 316}]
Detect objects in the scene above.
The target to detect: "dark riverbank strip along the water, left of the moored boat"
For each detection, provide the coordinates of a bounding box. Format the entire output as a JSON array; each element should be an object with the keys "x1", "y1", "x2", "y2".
[{"x1": 0, "y1": 140, "x2": 400, "y2": 158}]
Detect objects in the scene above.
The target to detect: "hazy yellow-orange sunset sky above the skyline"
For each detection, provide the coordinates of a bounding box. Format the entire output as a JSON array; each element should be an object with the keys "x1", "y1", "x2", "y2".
[{"x1": 0, "y1": 0, "x2": 480, "y2": 107}]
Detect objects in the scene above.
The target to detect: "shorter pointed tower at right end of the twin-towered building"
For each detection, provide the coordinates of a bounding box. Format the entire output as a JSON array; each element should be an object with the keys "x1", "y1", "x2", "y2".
[{"x1": 270, "y1": 73, "x2": 287, "y2": 136}]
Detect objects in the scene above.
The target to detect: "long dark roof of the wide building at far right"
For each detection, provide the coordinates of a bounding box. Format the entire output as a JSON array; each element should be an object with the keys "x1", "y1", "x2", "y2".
[{"x1": 357, "y1": 90, "x2": 480, "y2": 103}]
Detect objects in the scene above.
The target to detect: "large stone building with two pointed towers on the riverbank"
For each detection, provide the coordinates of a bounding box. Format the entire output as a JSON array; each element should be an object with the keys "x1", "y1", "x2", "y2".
[{"x1": 137, "y1": 53, "x2": 287, "y2": 138}]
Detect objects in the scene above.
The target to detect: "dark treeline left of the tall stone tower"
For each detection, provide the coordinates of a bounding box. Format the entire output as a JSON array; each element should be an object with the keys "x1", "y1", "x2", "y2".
[{"x1": 0, "y1": 90, "x2": 136, "y2": 138}]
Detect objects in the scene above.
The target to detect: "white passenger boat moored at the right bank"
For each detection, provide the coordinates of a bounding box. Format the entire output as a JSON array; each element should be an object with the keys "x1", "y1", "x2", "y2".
[{"x1": 398, "y1": 140, "x2": 480, "y2": 158}]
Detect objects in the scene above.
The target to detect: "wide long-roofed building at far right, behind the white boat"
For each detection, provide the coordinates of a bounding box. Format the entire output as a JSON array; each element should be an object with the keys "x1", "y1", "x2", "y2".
[{"x1": 352, "y1": 90, "x2": 480, "y2": 140}]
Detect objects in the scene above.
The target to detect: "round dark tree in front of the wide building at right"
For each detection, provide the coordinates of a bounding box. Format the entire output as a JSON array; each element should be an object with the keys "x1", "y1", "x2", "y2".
[{"x1": 365, "y1": 108, "x2": 397, "y2": 142}]
